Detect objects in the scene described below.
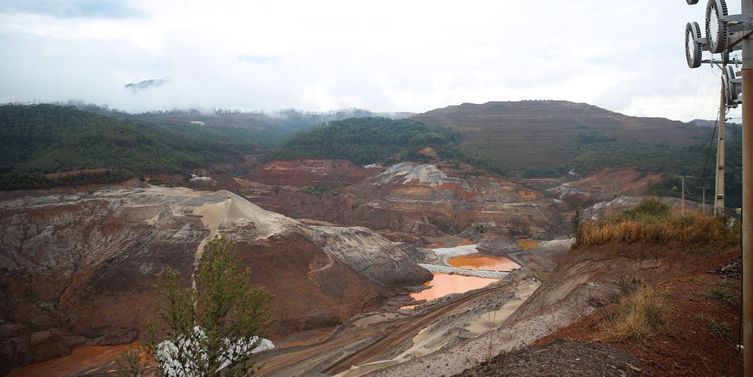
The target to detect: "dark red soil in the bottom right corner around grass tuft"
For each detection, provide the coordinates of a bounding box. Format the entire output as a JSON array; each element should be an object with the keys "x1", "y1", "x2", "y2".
[{"x1": 536, "y1": 251, "x2": 742, "y2": 376}]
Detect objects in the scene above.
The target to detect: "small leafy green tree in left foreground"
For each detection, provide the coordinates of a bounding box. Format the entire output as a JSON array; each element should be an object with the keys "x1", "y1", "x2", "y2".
[{"x1": 121, "y1": 237, "x2": 270, "y2": 377}]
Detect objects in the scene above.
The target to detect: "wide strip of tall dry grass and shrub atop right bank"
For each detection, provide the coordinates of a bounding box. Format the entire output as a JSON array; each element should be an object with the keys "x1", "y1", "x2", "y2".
[{"x1": 577, "y1": 198, "x2": 739, "y2": 246}]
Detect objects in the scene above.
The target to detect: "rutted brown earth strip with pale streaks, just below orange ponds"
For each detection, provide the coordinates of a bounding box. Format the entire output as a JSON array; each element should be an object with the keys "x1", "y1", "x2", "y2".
[{"x1": 250, "y1": 272, "x2": 538, "y2": 376}]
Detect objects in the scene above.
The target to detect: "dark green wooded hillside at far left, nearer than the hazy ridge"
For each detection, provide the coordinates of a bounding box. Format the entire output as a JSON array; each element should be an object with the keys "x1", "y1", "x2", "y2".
[{"x1": 0, "y1": 105, "x2": 258, "y2": 189}]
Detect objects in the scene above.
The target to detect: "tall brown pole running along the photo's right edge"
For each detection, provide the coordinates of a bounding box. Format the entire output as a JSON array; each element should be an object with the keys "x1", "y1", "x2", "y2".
[{"x1": 742, "y1": 0, "x2": 753, "y2": 370}]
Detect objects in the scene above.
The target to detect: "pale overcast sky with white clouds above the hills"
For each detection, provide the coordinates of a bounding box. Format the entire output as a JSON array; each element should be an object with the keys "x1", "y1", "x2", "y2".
[{"x1": 0, "y1": 0, "x2": 739, "y2": 120}]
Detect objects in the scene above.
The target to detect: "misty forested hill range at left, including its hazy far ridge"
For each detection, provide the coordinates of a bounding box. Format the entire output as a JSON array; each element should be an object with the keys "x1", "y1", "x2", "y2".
[{"x1": 0, "y1": 102, "x2": 414, "y2": 190}]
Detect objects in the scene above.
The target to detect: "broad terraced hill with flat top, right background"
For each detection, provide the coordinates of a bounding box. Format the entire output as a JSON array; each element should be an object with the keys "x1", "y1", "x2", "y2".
[{"x1": 412, "y1": 101, "x2": 711, "y2": 176}]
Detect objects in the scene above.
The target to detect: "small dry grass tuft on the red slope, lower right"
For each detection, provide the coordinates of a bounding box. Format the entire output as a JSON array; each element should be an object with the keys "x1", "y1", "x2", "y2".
[{"x1": 597, "y1": 286, "x2": 666, "y2": 342}]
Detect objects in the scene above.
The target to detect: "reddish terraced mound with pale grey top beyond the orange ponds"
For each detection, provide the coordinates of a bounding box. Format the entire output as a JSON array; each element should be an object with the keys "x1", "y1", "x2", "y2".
[{"x1": 241, "y1": 162, "x2": 570, "y2": 238}]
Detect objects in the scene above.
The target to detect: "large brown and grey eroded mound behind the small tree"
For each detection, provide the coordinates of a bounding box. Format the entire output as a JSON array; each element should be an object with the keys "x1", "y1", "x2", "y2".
[{"x1": 0, "y1": 187, "x2": 429, "y2": 366}]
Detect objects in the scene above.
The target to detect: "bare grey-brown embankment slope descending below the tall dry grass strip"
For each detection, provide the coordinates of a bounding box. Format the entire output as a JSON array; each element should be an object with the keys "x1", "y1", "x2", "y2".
[{"x1": 369, "y1": 243, "x2": 737, "y2": 377}]
